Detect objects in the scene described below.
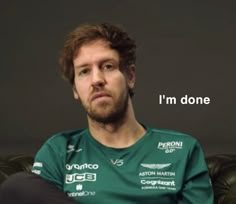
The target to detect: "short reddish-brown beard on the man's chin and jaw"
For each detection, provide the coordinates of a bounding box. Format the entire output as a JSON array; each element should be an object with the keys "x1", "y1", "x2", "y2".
[{"x1": 82, "y1": 89, "x2": 129, "y2": 124}]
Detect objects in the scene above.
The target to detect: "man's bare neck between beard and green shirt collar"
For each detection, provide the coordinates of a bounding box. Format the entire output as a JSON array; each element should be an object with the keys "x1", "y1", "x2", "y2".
[{"x1": 88, "y1": 99, "x2": 145, "y2": 148}]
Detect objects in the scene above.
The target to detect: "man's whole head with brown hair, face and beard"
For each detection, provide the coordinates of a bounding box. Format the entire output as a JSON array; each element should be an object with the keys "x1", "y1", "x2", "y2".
[{"x1": 60, "y1": 24, "x2": 136, "y2": 123}]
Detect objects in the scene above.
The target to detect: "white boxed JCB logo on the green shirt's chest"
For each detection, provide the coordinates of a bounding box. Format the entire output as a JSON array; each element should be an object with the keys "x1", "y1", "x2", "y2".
[{"x1": 65, "y1": 173, "x2": 96, "y2": 184}]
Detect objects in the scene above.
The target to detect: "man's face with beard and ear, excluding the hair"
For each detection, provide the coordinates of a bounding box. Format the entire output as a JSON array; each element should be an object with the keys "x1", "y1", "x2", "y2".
[{"x1": 73, "y1": 40, "x2": 135, "y2": 123}]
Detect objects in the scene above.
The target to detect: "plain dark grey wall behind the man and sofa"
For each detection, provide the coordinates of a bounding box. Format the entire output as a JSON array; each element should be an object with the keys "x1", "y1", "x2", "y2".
[{"x1": 0, "y1": 0, "x2": 236, "y2": 155}]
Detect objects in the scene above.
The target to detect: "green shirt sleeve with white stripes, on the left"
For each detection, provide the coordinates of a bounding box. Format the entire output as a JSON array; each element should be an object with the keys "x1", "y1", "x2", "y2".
[{"x1": 32, "y1": 139, "x2": 65, "y2": 190}]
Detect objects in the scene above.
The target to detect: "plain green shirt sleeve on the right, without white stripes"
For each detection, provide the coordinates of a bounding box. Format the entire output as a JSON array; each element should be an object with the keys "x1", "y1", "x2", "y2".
[{"x1": 178, "y1": 141, "x2": 214, "y2": 204}]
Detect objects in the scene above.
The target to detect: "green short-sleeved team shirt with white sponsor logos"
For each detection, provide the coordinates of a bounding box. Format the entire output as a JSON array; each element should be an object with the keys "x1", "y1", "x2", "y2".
[{"x1": 32, "y1": 127, "x2": 213, "y2": 204}]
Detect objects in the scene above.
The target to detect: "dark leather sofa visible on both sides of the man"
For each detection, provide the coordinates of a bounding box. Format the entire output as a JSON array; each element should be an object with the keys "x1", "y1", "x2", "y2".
[{"x1": 0, "y1": 154, "x2": 236, "y2": 204}]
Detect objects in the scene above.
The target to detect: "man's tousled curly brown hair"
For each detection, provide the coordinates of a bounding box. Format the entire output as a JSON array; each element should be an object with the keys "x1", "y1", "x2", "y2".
[{"x1": 59, "y1": 23, "x2": 136, "y2": 85}]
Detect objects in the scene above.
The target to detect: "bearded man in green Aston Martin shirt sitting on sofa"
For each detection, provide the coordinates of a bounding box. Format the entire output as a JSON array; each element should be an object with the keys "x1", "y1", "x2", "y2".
[{"x1": 0, "y1": 24, "x2": 213, "y2": 204}]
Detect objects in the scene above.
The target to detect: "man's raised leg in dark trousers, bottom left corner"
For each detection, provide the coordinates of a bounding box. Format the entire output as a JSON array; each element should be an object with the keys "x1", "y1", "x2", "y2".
[{"x1": 0, "y1": 172, "x2": 78, "y2": 204}]
